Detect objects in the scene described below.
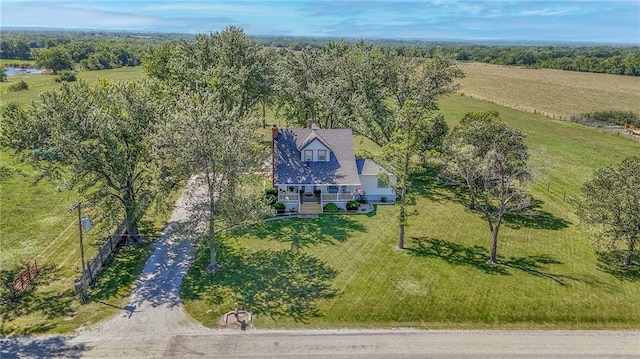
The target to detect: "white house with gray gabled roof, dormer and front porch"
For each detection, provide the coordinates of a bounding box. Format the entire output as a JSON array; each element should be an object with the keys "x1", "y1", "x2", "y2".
[{"x1": 271, "y1": 124, "x2": 396, "y2": 213}]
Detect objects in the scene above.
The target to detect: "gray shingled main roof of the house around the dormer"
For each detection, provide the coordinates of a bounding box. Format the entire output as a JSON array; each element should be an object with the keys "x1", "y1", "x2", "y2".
[{"x1": 274, "y1": 128, "x2": 360, "y2": 185}]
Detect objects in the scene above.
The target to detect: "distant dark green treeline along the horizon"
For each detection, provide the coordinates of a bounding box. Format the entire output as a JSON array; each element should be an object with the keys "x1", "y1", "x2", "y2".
[{"x1": 0, "y1": 30, "x2": 640, "y2": 76}]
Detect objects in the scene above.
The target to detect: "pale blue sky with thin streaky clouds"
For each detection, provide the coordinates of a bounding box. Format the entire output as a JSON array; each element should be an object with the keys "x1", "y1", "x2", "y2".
[{"x1": 0, "y1": 0, "x2": 640, "y2": 45}]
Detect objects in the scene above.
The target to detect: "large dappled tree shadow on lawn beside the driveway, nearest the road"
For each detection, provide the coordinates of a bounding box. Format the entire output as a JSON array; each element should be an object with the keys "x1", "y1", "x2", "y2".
[{"x1": 183, "y1": 247, "x2": 337, "y2": 323}]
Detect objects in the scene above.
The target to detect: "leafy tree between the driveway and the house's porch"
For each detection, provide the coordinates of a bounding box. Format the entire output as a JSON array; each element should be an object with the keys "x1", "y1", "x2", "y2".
[{"x1": 161, "y1": 91, "x2": 271, "y2": 271}]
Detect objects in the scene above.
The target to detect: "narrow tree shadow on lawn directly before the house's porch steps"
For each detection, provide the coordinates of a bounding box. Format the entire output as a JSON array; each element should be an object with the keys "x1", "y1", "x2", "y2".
[{"x1": 245, "y1": 215, "x2": 366, "y2": 249}]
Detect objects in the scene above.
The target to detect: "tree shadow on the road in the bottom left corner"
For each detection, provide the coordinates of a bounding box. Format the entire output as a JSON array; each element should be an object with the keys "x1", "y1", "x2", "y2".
[{"x1": 0, "y1": 336, "x2": 87, "y2": 359}]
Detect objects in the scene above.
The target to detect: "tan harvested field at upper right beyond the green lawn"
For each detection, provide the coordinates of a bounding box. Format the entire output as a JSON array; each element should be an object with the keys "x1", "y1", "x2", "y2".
[{"x1": 460, "y1": 63, "x2": 640, "y2": 119}]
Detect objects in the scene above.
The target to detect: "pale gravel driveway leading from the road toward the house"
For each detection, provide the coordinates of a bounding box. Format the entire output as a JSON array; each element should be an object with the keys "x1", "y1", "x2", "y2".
[{"x1": 74, "y1": 181, "x2": 212, "y2": 342}]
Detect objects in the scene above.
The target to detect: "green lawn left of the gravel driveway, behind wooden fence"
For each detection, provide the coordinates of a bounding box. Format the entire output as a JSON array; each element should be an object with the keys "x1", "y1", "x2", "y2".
[{"x1": 0, "y1": 152, "x2": 175, "y2": 336}]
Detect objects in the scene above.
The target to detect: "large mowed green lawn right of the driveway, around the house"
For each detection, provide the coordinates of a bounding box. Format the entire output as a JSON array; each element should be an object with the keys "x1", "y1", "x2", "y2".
[{"x1": 183, "y1": 96, "x2": 640, "y2": 329}]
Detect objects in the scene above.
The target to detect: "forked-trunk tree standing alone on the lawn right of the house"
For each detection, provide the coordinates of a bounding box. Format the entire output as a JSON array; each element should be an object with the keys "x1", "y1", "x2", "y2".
[{"x1": 445, "y1": 112, "x2": 532, "y2": 264}]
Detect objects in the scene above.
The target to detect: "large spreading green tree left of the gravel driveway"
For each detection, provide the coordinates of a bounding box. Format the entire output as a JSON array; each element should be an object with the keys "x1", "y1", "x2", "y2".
[{"x1": 1, "y1": 81, "x2": 174, "y2": 241}]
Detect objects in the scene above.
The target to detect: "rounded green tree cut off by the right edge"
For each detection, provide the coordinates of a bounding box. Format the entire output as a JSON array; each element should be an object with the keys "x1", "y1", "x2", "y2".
[{"x1": 578, "y1": 157, "x2": 640, "y2": 266}]
